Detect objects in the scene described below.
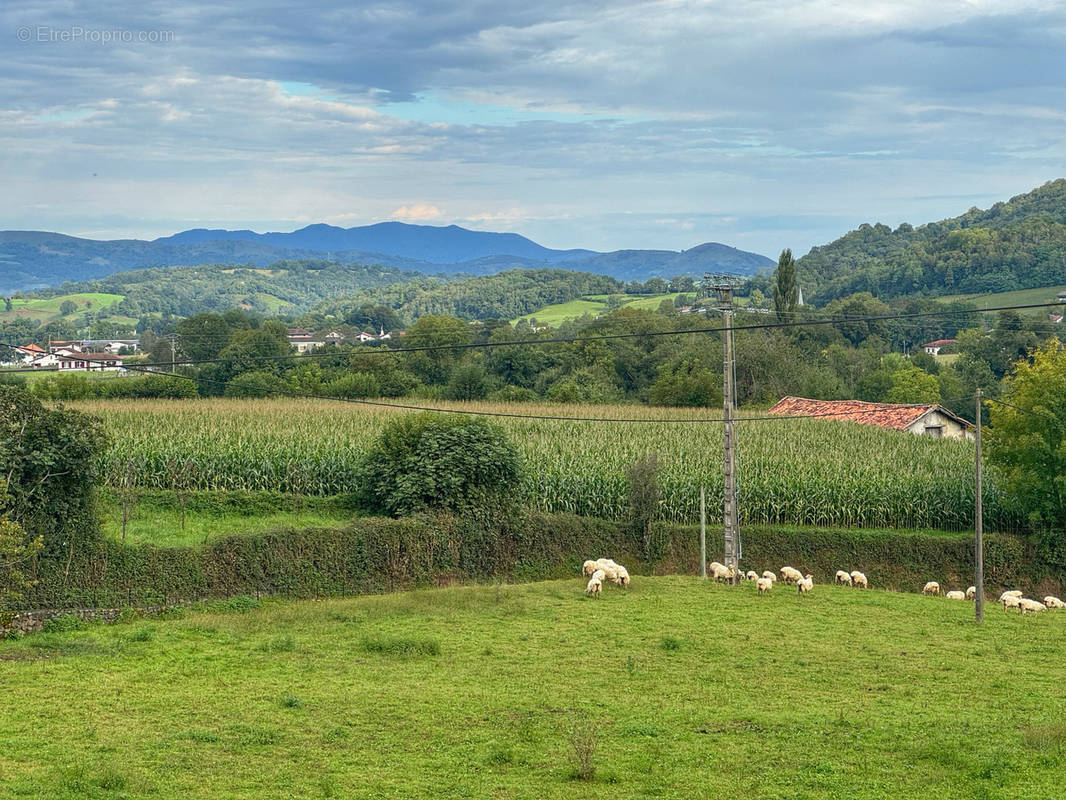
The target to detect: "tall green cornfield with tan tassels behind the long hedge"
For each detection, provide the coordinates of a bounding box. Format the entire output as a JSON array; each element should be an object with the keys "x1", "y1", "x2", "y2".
[{"x1": 75, "y1": 399, "x2": 1018, "y2": 530}]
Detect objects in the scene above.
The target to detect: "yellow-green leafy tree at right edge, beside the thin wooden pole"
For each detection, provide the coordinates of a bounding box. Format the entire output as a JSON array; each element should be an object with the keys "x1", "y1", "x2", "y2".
[{"x1": 988, "y1": 339, "x2": 1066, "y2": 535}]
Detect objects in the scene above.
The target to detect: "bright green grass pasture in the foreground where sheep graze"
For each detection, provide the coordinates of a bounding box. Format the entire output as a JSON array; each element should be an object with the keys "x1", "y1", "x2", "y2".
[{"x1": 0, "y1": 576, "x2": 1066, "y2": 800}]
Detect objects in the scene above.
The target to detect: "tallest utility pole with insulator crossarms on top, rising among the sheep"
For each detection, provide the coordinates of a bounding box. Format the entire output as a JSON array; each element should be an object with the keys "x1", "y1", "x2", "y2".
[{"x1": 704, "y1": 274, "x2": 744, "y2": 582}]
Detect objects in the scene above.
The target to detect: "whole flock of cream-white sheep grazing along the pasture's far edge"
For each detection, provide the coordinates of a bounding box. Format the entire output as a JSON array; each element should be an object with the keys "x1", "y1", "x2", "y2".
[{"x1": 581, "y1": 558, "x2": 1066, "y2": 614}]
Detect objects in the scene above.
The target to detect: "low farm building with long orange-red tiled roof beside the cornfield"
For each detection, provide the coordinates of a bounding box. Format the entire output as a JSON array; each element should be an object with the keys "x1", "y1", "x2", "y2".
[{"x1": 769, "y1": 397, "x2": 973, "y2": 439}]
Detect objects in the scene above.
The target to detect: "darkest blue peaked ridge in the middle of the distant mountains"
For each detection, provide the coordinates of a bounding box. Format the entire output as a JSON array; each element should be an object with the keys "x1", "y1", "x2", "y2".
[{"x1": 156, "y1": 222, "x2": 596, "y2": 263}]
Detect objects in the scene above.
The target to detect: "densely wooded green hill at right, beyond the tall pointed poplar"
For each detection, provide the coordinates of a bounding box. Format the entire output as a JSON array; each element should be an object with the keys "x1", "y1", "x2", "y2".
[{"x1": 797, "y1": 179, "x2": 1066, "y2": 304}]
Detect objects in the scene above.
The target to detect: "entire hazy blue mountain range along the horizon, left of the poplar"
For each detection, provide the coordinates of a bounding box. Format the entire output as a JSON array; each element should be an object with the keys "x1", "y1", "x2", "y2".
[{"x1": 0, "y1": 222, "x2": 774, "y2": 295}]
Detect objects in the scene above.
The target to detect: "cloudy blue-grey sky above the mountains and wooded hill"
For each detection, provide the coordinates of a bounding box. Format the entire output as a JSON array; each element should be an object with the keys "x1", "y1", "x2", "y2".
[{"x1": 0, "y1": 0, "x2": 1066, "y2": 258}]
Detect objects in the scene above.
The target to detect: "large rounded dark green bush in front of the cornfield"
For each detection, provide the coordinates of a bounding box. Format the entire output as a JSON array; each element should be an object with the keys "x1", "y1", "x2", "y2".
[{"x1": 358, "y1": 414, "x2": 522, "y2": 516}]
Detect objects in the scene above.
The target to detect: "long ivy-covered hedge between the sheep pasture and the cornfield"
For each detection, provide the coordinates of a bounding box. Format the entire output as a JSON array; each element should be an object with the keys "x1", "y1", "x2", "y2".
[{"x1": 22, "y1": 513, "x2": 1064, "y2": 608}]
